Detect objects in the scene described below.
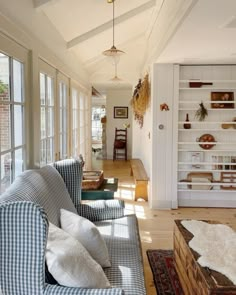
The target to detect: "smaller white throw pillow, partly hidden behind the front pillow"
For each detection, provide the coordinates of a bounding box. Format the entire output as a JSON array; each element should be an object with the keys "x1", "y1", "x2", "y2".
[{"x1": 60, "y1": 209, "x2": 111, "y2": 267}]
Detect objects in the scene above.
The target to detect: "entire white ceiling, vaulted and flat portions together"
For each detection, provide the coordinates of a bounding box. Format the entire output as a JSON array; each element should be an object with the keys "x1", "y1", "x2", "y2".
[{"x1": 0, "y1": 0, "x2": 236, "y2": 93}]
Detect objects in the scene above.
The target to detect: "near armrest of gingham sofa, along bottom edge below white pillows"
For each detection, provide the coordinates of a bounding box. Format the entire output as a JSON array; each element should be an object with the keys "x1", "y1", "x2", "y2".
[{"x1": 43, "y1": 285, "x2": 124, "y2": 295}]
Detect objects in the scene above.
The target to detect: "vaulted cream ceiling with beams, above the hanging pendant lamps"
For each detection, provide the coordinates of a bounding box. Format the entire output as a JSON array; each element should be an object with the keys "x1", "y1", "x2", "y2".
[{"x1": 33, "y1": 0, "x2": 196, "y2": 91}]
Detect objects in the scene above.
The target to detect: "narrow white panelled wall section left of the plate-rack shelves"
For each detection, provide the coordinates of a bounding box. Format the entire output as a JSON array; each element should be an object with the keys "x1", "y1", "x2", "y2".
[{"x1": 149, "y1": 64, "x2": 177, "y2": 209}]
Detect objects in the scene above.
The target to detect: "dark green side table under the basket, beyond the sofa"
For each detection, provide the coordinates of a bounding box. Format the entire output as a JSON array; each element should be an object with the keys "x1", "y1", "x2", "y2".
[{"x1": 81, "y1": 178, "x2": 118, "y2": 200}]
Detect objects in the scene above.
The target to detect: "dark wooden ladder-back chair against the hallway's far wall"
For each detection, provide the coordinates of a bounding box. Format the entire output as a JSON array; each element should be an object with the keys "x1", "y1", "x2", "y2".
[{"x1": 113, "y1": 128, "x2": 127, "y2": 161}]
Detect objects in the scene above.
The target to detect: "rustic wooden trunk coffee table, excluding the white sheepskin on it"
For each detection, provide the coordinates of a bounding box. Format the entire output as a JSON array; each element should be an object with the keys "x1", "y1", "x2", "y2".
[{"x1": 174, "y1": 220, "x2": 236, "y2": 295}]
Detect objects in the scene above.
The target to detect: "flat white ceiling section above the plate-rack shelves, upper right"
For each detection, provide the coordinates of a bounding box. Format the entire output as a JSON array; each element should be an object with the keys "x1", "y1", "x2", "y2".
[{"x1": 158, "y1": 0, "x2": 236, "y2": 64}]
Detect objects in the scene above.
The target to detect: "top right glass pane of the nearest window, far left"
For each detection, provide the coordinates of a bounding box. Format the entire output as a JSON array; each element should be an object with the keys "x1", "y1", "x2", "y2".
[{"x1": 13, "y1": 59, "x2": 24, "y2": 102}]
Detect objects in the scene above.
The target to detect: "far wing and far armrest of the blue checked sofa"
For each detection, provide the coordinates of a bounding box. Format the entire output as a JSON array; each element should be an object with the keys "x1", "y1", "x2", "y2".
[{"x1": 53, "y1": 157, "x2": 124, "y2": 221}]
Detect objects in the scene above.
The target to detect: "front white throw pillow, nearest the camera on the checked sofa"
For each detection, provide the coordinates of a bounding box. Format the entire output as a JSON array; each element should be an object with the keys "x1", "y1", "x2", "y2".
[{"x1": 46, "y1": 223, "x2": 110, "y2": 288}]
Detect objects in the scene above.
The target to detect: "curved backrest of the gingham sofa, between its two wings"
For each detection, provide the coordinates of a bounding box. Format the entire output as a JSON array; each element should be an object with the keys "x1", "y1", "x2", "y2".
[{"x1": 1, "y1": 166, "x2": 77, "y2": 226}]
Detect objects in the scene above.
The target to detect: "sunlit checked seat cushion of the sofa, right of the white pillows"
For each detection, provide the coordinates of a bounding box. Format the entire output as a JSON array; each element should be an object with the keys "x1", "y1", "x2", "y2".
[{"x1": 95, "y1": 215, "x2": 146, "y2": 295}]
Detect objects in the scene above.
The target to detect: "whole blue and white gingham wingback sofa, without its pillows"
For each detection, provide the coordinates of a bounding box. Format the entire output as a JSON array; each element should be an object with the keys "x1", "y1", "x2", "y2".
[{"x1": 0, "y1": 160, "x2": 146, "y2": 295}]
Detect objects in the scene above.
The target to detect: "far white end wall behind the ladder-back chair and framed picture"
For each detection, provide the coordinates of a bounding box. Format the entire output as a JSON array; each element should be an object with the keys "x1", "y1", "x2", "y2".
[{"x1": 106, "y1": 87, "x2": 133, "y2": 159}]
